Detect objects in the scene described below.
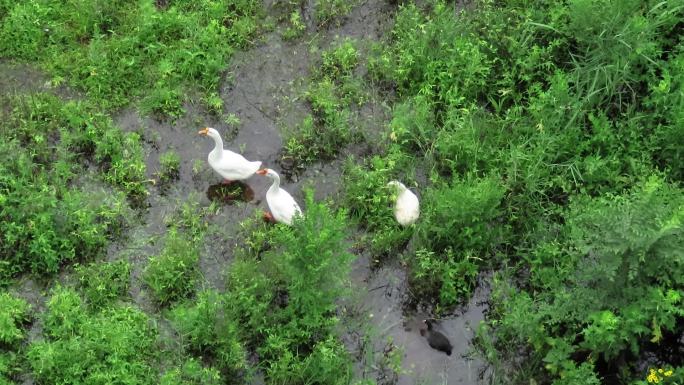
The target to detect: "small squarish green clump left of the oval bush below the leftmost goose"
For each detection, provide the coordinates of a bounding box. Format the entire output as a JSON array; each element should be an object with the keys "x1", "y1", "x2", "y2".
[{"x1": 76, "y1": 260, "x2": 131, "y2": 308}]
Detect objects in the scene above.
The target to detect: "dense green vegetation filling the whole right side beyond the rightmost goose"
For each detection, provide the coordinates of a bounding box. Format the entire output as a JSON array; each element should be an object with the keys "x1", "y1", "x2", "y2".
[{"x1": 345, "y1": 0, "x2": 684, "y2": 384}]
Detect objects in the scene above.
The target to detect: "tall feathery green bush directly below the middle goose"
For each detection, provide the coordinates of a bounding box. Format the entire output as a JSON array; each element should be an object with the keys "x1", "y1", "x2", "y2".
[{"x1": 225, "y1": 192, "x2": 353, "y2": 384}]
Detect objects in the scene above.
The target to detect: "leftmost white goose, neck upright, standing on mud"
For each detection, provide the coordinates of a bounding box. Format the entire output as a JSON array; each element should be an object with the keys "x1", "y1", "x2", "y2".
[{"x1": 198, "y1": 127, "x2": 261, "y2": 183}]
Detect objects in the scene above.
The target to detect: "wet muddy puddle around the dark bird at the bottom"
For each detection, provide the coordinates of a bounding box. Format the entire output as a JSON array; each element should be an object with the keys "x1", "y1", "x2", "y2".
[{"x1": 347, "y1": 250, "x2": 489, "y2": 385}]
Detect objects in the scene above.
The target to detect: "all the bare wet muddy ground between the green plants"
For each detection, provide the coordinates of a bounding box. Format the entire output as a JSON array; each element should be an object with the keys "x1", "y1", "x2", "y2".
[{"x1": 0, "y1": 0, "x2": 488, "y2": 384}]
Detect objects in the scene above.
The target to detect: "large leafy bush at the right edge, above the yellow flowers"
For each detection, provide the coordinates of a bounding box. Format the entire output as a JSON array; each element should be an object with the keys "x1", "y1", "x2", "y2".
[{"x1": 484, "y1": 178, "x2": 684, "y2": 377}]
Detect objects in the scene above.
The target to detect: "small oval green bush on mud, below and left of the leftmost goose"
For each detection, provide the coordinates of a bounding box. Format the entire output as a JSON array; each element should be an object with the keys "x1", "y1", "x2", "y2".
[{"x1": 143, "y1": 228, "x2": 199, "y2": 304}]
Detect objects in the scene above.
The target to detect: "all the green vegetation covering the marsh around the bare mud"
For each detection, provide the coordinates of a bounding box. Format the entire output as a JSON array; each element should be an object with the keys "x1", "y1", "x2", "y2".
[{"x1": 0, "y1": 0, "x2": 684, "y2": 385}]
